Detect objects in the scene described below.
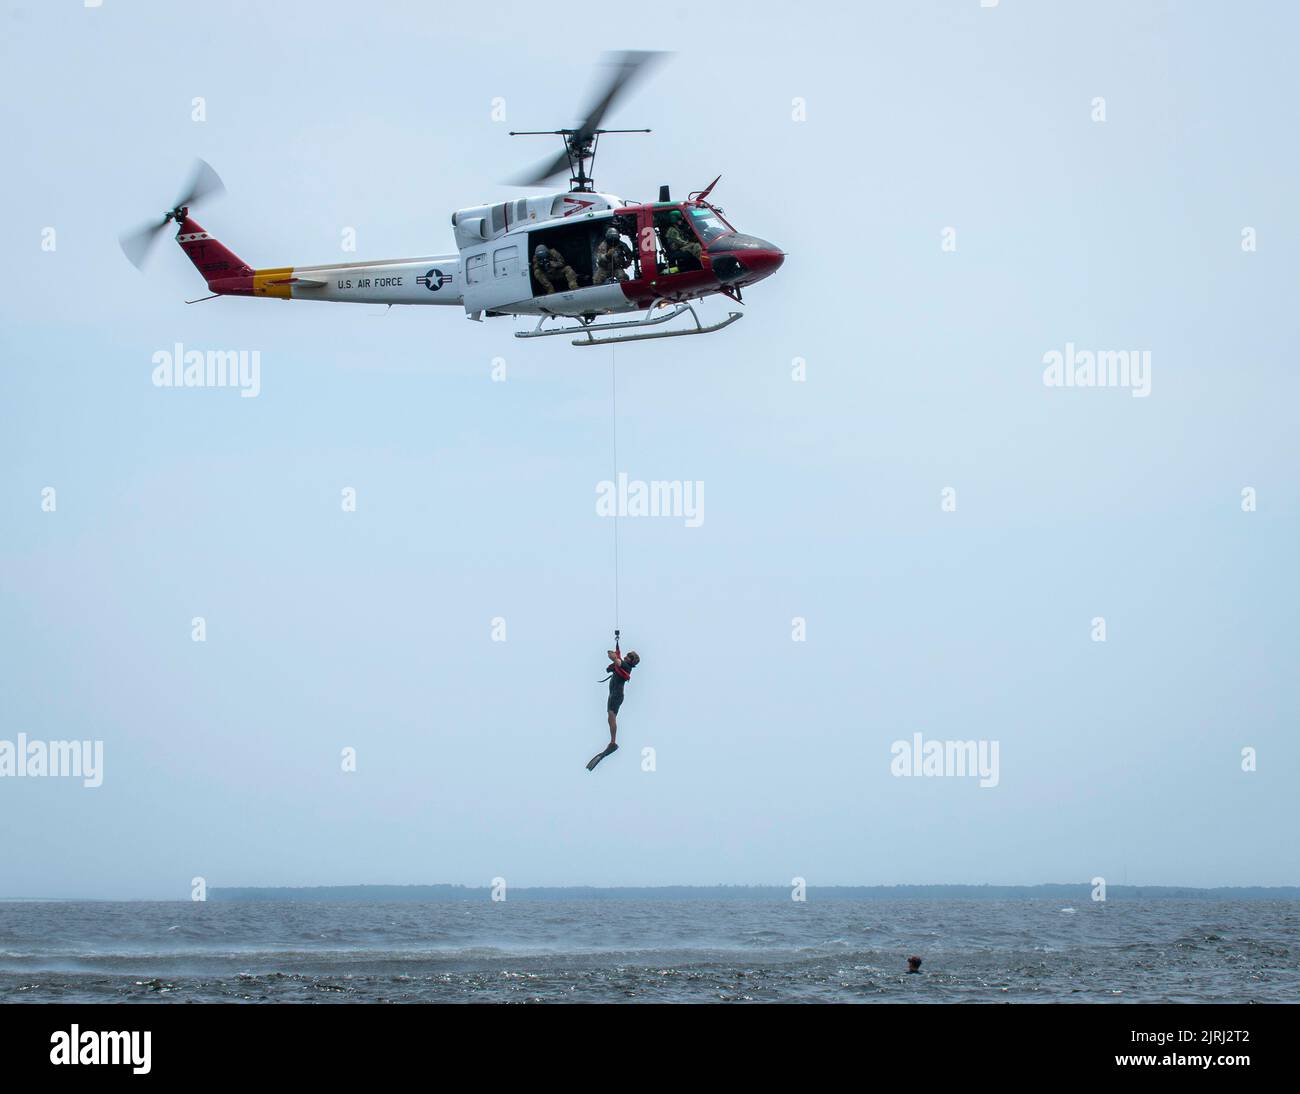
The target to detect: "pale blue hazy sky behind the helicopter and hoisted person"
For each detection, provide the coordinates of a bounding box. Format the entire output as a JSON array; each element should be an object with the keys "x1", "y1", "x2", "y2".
[{"x1": 0, "y1": 0, "x2": 1300, "y2": 899}]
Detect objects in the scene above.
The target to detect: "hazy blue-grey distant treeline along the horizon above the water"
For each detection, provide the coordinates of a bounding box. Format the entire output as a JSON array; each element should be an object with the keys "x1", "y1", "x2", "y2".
[{"x1": 208, "y1": 884, "x2": 1300, "y2": 903}]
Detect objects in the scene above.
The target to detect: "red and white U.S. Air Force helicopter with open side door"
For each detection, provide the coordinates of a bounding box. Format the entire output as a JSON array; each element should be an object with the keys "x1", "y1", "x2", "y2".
[{"x1": 120, "y1": 51, "x2": 785, "y2": 346}]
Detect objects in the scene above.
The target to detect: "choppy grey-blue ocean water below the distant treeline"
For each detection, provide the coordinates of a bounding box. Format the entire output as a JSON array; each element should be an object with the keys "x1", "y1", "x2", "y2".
[{"x1": 0, "y1": 899, "x2": 1300, "y2": 1003}]
